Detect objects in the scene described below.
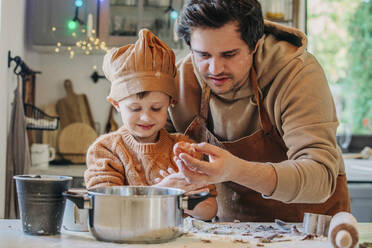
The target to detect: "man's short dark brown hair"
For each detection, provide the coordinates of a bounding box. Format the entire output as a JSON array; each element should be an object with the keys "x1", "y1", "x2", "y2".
[{"x1": 177, "y1": 0, "x2": 264, "y2": 50}]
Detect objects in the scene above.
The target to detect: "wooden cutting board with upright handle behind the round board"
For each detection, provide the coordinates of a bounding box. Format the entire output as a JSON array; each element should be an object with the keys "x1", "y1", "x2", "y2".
[{"x1": 57, "y1": 79, "x2": 94, "y2": 128}]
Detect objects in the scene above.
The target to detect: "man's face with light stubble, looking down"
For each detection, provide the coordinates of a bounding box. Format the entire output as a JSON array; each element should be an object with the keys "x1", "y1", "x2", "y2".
[{"x1": 190, "y1": 22, "x2": 253, "y2": 94}]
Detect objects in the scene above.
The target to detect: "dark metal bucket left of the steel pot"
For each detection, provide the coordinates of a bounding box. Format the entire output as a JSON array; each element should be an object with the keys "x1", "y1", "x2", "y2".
[{"x1": 13, "y1": 175, "x2": 72, "y2": 235}]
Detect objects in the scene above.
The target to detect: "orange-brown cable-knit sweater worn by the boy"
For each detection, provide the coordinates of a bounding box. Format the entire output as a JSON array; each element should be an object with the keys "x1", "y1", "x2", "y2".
[{"x1": 84, "y1": 128, "x2": 215, "y2": 195}]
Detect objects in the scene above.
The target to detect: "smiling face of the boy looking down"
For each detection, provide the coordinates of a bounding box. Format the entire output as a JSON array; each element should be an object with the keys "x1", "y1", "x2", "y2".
[{"x1": 119, "y1": 91, "x2": 169, "y2": 143}]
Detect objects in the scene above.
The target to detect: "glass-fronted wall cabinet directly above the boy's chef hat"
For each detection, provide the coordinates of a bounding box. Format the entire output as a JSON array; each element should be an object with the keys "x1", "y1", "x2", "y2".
[{"x1": 98, "y1": 0, "x2": 184, "y2": 49}]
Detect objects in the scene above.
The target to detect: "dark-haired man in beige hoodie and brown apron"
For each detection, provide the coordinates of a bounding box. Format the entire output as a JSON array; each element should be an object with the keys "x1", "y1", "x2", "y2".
[{"x1": 164, "y1": 0, "x2": 350, "y2": 221}]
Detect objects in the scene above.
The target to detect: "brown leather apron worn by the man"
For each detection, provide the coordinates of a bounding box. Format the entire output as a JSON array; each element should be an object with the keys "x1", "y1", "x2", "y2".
[{"x1": 185, "y1": 68, "x2": 350, "y2": 222}]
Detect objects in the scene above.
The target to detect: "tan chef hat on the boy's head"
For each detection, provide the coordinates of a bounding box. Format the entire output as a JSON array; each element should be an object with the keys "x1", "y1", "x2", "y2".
[{"x1": 103, "y1": 29, "x2": 177, "y2": 102}]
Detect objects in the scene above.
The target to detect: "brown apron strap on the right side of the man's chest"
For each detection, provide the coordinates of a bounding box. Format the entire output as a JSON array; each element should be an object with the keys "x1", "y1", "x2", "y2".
[{"x1": 250, "y1": 65, "x2": 273, "y2": 134}]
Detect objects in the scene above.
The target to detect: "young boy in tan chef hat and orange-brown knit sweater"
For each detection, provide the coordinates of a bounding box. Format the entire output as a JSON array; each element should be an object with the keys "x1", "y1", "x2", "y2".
[{"x1": 84, "y1": 29, "x2": 217, "y2": 219}]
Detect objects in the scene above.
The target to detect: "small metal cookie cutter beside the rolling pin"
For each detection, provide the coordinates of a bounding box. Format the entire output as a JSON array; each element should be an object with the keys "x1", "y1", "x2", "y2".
[{"x1": 303, "y1": 213, "x2": 332, "y2": 237}]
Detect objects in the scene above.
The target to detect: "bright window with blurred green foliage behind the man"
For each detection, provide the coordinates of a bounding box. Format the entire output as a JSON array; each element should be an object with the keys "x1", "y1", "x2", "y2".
[{"x1": 307, "y1": 0, "x2": 372, "y2": 152}]
